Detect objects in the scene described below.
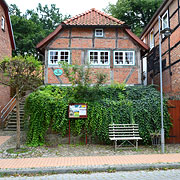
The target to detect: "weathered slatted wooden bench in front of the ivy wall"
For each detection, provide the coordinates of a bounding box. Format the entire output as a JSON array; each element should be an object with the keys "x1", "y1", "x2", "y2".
[{"x1": 109, "y1": 124, "x2": 142, "y2": 151}]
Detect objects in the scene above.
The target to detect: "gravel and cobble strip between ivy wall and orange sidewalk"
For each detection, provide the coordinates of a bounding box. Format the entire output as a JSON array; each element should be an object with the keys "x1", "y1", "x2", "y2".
[{"x1": 0, "y1": 131, "x2": 180, "y2": 159}]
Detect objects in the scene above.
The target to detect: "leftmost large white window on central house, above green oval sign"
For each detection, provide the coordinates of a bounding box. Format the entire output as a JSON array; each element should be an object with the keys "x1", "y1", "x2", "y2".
[{"x1": 48, "y1": 50, "x2": 70, "y2": 66}]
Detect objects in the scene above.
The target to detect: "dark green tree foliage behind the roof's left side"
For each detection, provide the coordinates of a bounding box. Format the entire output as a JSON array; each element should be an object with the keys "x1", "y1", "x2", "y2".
[{"x1": 10, "y1": 3, "x2": 69, "y2": 56}]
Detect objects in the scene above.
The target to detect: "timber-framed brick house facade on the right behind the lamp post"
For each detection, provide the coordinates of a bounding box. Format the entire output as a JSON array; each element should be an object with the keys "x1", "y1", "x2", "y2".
[{"x1": 141, "y1": 0, "x2": 180, "y2": 99}]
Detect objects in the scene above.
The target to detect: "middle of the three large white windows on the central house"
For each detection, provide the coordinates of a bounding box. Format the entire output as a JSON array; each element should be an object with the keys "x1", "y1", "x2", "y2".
[{"x1": 89, "y1": 50, "x2": 110, "y2": 65}]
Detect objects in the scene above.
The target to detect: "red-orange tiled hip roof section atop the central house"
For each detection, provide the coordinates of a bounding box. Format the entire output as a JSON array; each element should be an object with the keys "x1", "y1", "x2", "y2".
[{"x1": 63, "y1": 8, "x2": 124, "y2": 25}]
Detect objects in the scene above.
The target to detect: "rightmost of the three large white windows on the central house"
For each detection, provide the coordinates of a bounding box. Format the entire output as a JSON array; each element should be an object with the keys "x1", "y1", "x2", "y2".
[{"x1": 114, "y1": 51, "x2": 135, "y2": 65}]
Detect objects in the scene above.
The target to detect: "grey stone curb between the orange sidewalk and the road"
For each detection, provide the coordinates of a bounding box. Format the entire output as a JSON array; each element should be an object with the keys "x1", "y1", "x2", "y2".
[{"x1": 0, "y1": 163, "x2": 180, "y2": 175}]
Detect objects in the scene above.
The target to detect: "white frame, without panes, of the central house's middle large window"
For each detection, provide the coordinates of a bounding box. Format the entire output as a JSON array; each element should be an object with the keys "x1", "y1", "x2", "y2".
[{"x1": 88, "y1": 50, "x2": 110, "y2": 66}]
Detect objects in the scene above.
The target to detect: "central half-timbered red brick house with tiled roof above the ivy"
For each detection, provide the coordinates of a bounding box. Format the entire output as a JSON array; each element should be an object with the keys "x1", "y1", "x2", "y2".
[{"x1": 37, "y1": 9, "x2": 149, "y2": 85}]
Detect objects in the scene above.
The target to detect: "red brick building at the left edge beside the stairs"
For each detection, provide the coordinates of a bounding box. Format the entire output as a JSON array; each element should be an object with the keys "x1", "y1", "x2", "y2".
[{"x1": 0, "y1": 0, "x2": 15, "y2": 109}]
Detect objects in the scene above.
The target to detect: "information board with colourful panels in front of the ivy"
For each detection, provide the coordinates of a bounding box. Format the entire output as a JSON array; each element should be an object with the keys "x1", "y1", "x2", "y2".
[{"x1": 68, "y1": 103, "x2": 87, "y2": 118}]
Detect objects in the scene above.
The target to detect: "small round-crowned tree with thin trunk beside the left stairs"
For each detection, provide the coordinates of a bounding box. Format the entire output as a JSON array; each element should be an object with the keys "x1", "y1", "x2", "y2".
[{"x1": 0, "y1": 56, "x2": 42, "y2": 149}]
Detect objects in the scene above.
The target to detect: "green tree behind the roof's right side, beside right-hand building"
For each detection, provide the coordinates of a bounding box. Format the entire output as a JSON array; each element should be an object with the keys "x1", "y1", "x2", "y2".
[{"x1": 105, "y1": 0, "x2": 163, "y2": 35}]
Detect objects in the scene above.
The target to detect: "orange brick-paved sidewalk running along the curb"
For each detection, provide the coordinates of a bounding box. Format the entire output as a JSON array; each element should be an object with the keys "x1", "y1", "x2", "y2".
[{"x1": 0, "y1": 154, "x2": 180, "y2": 169}]
